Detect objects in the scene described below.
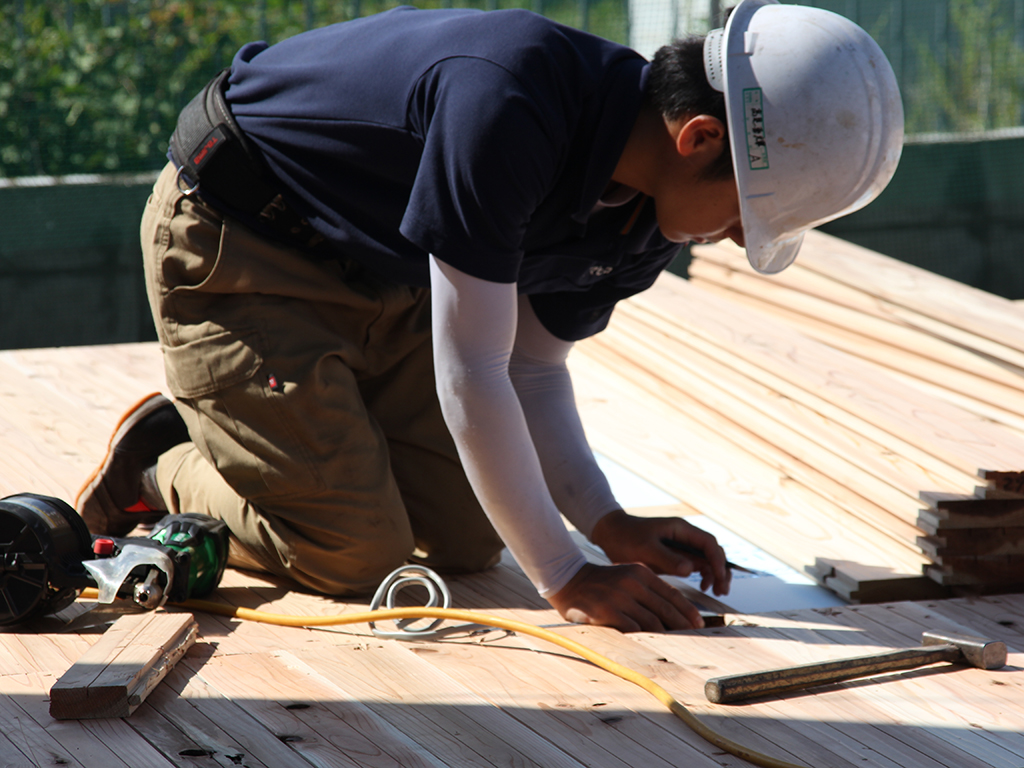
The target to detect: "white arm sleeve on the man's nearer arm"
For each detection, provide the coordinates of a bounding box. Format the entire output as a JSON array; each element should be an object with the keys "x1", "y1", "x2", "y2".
[{"x1": 430, "y1": 257, "x2": 613, "y2": 597}]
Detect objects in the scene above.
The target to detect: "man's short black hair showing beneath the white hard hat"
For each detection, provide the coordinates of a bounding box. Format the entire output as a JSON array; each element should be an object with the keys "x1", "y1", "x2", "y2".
[{"x1": 644, "y1": 37, "x2": 734, "y2": 179}]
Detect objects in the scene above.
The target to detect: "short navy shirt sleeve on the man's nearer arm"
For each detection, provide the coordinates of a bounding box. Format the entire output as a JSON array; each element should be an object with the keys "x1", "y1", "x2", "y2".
[{"x1": 400, "y1": 56, "x2": 568, "y2": 283}]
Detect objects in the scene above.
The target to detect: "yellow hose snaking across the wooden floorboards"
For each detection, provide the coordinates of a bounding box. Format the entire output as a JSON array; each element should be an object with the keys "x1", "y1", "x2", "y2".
[{"x1": 82, "y1": 589, "x2": 807, "y2": 768}]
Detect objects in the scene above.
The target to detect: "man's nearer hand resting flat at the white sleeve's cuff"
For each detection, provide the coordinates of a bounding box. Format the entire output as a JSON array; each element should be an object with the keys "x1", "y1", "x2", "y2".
[{"x1": 548, "y1": 563, "x2": 703, "y2": 632}]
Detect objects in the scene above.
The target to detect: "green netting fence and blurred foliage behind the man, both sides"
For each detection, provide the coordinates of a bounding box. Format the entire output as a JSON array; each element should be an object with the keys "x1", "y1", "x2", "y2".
[{"x1": 0, "y1": 0, "x2": 1024, "y2": 348}]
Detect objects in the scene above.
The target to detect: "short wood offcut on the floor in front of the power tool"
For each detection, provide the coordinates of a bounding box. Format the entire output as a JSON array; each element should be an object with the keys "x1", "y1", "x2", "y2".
[{"x1": 50, "y1": 611, "x2": 199, "y2": 720}]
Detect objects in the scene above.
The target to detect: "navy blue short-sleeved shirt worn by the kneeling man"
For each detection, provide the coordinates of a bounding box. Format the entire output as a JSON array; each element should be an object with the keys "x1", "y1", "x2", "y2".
[{"x1": 227, "y1": 8, "x2": 678, "y2": 340}]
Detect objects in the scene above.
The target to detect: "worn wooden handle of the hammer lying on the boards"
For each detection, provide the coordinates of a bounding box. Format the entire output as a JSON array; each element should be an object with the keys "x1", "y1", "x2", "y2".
[{"x1": 705, "y1": 645, "x2": 964, "y2": 703}]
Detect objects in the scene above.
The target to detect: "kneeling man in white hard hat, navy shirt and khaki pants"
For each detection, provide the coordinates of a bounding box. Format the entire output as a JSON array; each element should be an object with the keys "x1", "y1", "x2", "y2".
[{"x1": 78, "y1": 0, "x2": 902, "y2": 631}]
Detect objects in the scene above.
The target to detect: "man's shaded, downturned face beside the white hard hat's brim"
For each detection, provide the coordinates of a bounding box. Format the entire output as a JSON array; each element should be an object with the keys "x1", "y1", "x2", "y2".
[{"x1": 654, "y1": 178, "x2": 743, "y2": 246}]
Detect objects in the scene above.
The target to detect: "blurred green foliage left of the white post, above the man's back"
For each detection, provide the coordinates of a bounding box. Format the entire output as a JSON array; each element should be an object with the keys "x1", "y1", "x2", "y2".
[{"x1": 0, "y1": 0, "x2": 628, "y2": 177}]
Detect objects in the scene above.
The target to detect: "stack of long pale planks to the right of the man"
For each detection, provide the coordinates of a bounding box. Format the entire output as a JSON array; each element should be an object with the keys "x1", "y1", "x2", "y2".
[{"x1": 571, "y1": 232, "x2": 1024, "y2": 602}]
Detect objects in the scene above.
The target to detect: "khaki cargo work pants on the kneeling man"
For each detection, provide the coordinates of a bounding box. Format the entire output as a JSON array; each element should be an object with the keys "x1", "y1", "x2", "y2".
[{"x1": 141, "y1": 166, "x2": 503, "y2": 595}]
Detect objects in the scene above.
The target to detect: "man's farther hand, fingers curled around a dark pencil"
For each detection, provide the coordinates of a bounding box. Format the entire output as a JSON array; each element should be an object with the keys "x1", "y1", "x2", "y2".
[{"x1": 591, "y1": 510, "x2": 732, "y2": 595}]
